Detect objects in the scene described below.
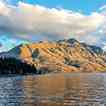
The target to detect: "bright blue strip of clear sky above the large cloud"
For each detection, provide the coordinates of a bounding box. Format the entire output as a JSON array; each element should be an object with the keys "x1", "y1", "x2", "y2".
[{"x1": 8, "y1": 0, "x2": 106, "y2": 14}]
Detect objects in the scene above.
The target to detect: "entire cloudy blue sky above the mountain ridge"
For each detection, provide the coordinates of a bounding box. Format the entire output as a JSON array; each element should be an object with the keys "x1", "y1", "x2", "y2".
[{"x1": 0, "y1": 0, "x2": 106, "y2": 52}]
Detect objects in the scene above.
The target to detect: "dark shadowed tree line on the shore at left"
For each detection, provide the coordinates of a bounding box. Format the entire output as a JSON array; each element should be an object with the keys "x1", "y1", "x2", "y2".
[{"x1": 0, "y1": 57, "x2": 37, "y2": 75}]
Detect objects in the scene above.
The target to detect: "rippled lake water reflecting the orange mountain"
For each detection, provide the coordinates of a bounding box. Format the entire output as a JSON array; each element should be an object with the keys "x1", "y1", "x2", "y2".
[{"x1": 0, "y1": 73, "x2": 106, "y2": 106}]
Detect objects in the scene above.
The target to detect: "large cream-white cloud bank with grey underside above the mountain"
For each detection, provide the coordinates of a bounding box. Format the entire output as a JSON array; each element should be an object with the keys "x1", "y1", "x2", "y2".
[{"x1": 0, "y1": 2, "x2": 105, "y2": 43}]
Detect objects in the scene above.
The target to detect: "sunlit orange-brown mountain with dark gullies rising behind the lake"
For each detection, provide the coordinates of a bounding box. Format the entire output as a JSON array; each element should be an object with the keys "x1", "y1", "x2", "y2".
[{"x1": 0, "y1": 39, "x2": 106, "y2": 72}]
